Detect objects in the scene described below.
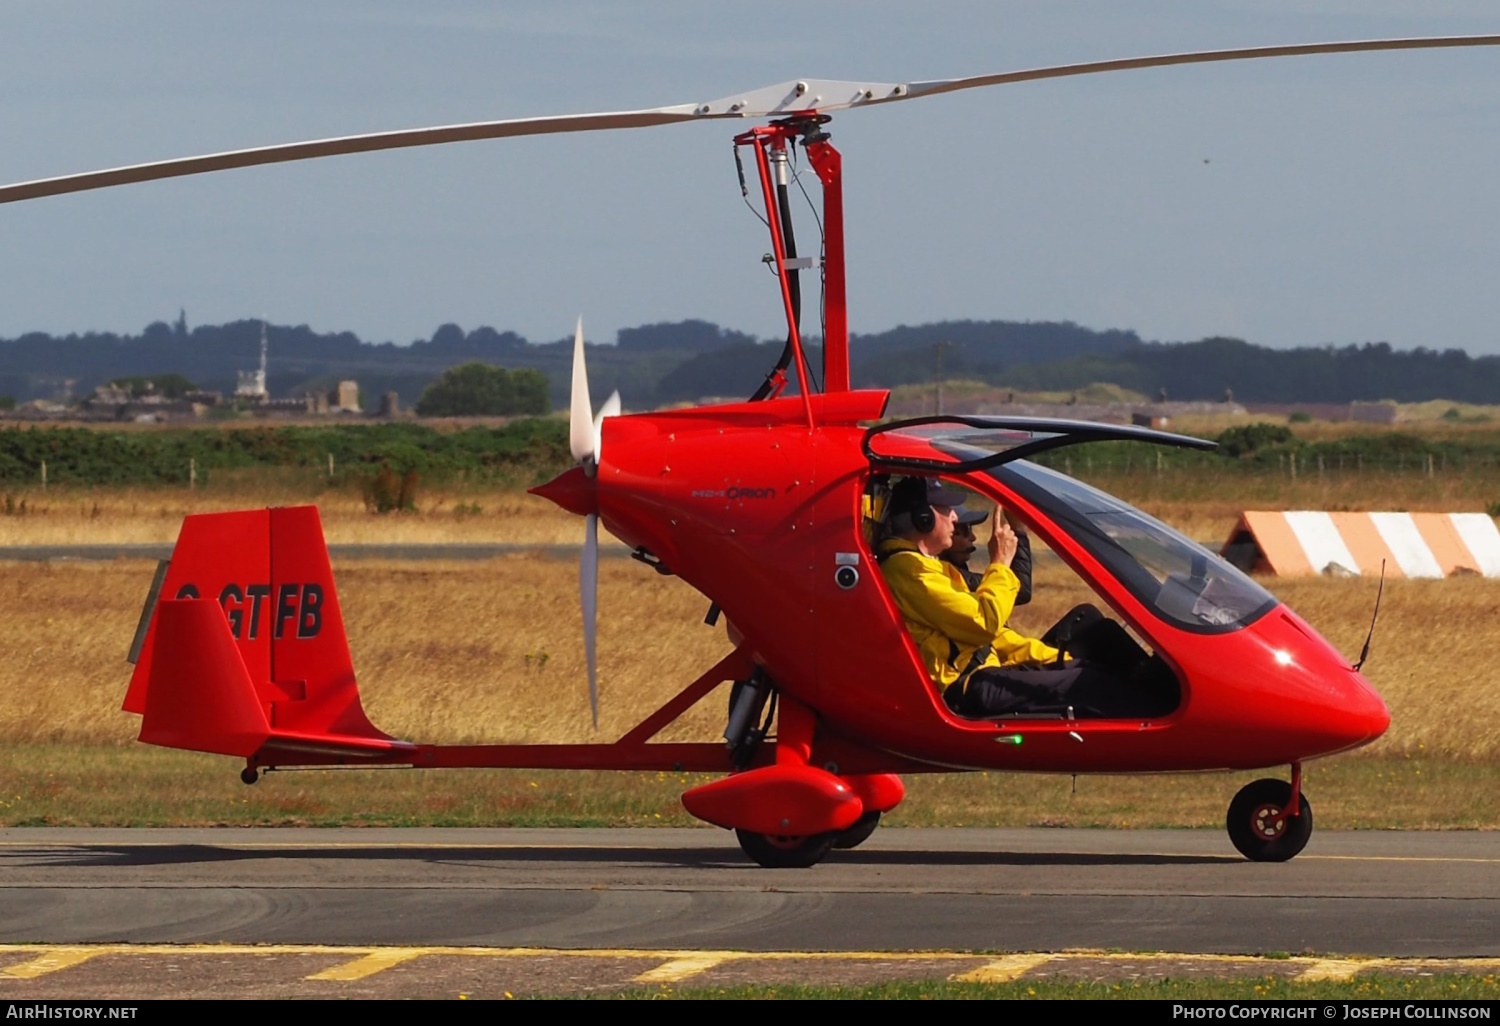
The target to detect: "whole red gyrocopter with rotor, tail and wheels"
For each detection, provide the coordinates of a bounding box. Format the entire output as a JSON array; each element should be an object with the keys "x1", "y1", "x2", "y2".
[{"x1": 0, "y1": 36, "x2": 1500, "y2": 867}]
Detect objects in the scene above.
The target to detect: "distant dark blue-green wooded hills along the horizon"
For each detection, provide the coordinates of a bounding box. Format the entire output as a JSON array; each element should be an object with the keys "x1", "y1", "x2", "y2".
[{"x1": 0, "y1": 318, "x2": 1500, "y2": 408}]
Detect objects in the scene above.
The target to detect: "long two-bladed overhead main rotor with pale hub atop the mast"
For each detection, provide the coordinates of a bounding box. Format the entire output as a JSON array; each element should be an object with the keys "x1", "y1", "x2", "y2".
[{"x1": 0, "y1": 35, "x2": 1500, "y2": 207}]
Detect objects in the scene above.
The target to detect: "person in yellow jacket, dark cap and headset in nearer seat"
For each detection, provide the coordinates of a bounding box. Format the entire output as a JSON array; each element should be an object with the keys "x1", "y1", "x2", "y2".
[{"x1": 878, "y1": 477, "x2": 1145, "y2": 719}]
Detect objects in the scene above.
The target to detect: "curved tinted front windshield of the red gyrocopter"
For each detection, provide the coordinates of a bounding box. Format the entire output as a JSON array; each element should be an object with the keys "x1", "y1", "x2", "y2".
[{"x1": 984, "y1": 459, "x2": 1277, "y2": 633}]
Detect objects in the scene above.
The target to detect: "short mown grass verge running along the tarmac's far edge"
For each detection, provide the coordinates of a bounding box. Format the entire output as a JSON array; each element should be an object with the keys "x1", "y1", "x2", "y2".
[{"x1": 0, "y1": 744, "x2": 1500, "y2": 830}]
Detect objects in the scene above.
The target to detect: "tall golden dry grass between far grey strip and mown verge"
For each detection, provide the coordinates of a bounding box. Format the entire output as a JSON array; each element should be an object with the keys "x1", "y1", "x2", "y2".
[{"x1": 0, "y1": 555, "x2": 1500, "y2": 761}]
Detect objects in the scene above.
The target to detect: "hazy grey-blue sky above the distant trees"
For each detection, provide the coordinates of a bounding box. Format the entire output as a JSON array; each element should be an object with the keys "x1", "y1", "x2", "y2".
[{"x1": 0, "y1": 0, "x2": 1500, "y2": 356}]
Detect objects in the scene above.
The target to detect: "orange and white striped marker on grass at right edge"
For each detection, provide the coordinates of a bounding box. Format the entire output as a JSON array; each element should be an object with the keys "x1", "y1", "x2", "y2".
[{"x1": 1220, "y1": 510, "x2": 1500, "y2": 578}]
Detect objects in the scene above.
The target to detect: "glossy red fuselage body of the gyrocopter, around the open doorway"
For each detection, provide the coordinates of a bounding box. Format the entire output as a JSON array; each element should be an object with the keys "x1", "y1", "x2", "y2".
[{"x1": 537, "y1": 392, "x2": 1389, "y2": 773}]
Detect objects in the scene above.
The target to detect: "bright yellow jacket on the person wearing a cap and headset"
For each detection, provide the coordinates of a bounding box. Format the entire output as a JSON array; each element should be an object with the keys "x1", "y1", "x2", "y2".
[{"x1": 881, "y1": 539, "x2": 1058, "y2": 690}]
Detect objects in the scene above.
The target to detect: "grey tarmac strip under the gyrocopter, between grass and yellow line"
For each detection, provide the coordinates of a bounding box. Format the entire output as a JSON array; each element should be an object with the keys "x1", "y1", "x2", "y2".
[{"x1": 0, "y1": 828, "x2": 1500, "y2": 957}]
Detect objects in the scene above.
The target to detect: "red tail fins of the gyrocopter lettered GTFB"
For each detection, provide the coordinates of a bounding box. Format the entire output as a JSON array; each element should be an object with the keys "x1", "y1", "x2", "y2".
[{"x1": 125, "y1": 506, "x2": 410, "y2": 755}]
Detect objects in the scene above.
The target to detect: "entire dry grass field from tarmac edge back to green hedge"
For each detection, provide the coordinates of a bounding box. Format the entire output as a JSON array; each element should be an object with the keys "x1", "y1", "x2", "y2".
[{"x1": 0, "y1": 477, "x2": 1500, "y2": 827}]
